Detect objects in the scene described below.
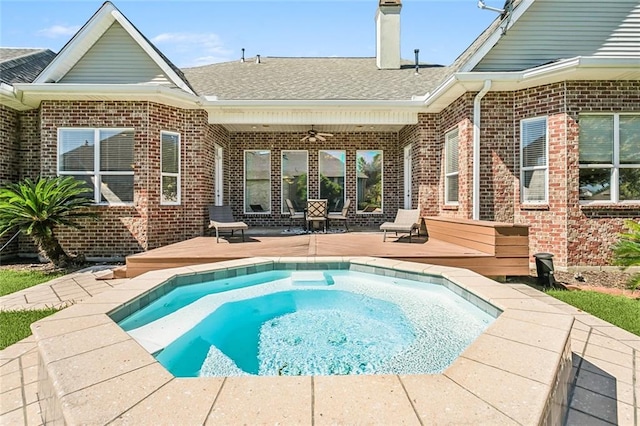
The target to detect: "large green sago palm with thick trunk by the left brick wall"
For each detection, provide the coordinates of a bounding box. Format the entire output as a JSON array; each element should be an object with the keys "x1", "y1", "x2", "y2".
[{"x1": 0, "y1": 176, "x2": 96, "y2": 267}]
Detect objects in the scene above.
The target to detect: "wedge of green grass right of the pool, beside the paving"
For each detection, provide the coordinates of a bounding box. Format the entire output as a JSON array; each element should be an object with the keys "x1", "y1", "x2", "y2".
[{"x1": 547, "y1": 290, "x2": 640, "y2": 336}]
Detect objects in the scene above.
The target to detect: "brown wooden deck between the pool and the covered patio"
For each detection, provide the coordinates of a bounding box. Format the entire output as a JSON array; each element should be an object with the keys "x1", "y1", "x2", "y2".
[{"x1": 126, "y1": 221, "x2": 529, "y2": 277}]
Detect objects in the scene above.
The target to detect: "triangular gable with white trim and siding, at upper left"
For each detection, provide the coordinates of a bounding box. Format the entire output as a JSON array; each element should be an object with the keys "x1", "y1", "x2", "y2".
[{"x1": 34, "y1": 2, "x2": 194, "y2": 94}]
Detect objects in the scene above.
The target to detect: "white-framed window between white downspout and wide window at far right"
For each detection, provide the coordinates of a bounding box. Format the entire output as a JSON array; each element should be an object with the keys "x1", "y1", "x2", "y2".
[{"x1": 520, "y1": 117, "x2": 549, "y2": 204}]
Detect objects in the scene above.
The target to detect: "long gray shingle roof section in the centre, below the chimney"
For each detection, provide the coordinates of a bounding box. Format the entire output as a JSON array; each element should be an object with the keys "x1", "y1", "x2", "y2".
[{"x1": 183, "y1": 57, "x2": 450, "y2": 100}]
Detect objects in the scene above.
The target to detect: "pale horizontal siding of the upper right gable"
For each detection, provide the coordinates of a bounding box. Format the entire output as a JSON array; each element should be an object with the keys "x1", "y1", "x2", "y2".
[{"x1": 468, "y1": 0, "x2": 640, "y2": 71}]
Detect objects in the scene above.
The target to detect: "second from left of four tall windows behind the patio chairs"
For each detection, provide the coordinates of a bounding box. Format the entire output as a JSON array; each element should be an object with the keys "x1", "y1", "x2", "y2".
[{"x1": 282, "y1": 151, "x2": 309, "y2": 213}]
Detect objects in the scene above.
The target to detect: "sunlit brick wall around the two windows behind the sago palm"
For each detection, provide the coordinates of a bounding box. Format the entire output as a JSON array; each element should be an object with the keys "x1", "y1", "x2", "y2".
[{"x1": 41, "y1": 101, "x2": 219, "y2": 256}]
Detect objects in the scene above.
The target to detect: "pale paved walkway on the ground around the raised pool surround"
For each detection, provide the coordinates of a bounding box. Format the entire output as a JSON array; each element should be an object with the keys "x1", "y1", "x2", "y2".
[{"x1": 0, "y1": 266, "x2": 640, "y2": 426}]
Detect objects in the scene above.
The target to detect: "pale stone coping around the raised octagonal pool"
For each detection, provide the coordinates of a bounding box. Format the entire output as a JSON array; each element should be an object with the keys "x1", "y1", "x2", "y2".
[{"x1": 32, "y1": 257, "x2": 573, "y2": 424}]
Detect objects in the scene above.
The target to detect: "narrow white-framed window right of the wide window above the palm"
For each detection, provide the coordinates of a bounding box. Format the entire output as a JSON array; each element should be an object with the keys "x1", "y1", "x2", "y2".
[{"x1": 160, "y1": 132, "x2": 180, "y2": 204}]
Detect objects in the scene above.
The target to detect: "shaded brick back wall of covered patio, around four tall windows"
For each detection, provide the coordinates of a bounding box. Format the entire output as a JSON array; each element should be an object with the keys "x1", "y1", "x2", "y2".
[{"x1": 228, "y1": 132, "x2": 403, "y2": 227}]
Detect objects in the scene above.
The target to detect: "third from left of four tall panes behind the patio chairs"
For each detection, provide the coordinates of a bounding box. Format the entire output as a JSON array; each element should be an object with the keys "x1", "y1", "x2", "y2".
[{"x1": 318, "y1": 151, "x2": 346, "y2": 212}]
